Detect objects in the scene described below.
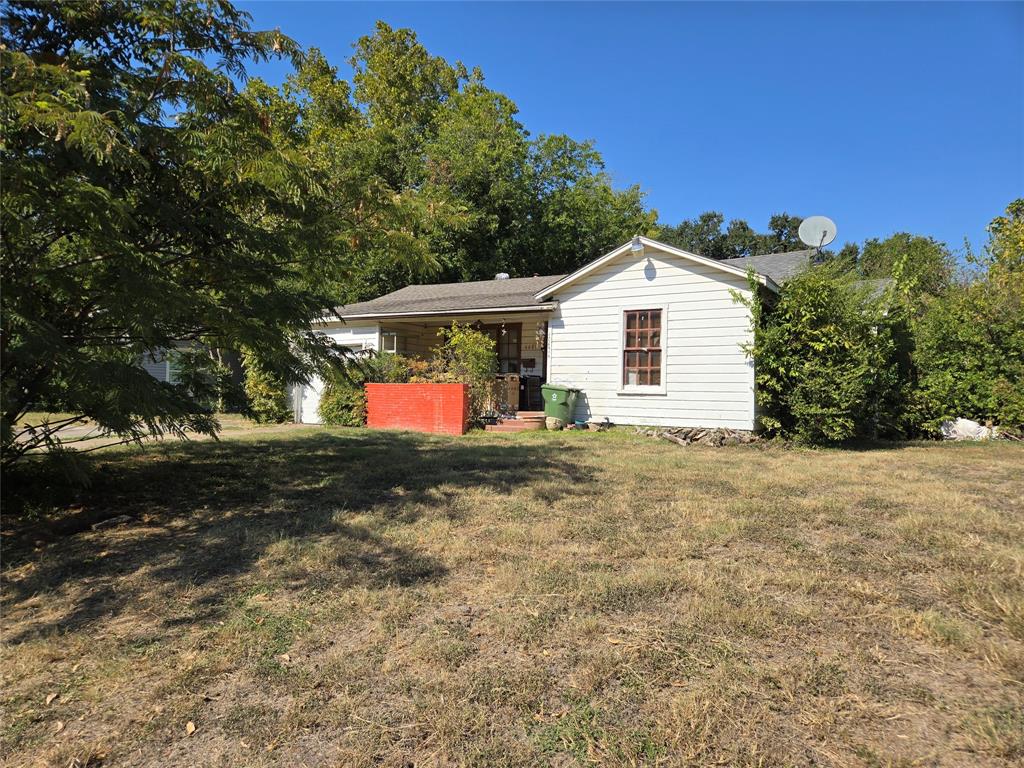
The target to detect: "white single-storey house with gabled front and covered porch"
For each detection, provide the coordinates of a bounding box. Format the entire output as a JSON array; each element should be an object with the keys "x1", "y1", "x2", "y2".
[{"x1": 296, "y1": 238, "x2": 813, "y2": 429}]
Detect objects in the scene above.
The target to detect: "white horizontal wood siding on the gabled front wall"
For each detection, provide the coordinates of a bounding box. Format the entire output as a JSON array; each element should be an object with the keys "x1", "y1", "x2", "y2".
[{"x1": 548, "y1": 246, "x2": 754, "y2": 429}]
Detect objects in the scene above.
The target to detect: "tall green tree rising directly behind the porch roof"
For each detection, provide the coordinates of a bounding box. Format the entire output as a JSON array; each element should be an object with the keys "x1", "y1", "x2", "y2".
[{"x1": 346, "y1": 22, "x2": 655, "y2": 299}]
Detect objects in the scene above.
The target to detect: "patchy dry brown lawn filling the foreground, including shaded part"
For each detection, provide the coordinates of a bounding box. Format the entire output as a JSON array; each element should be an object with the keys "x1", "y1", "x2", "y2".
[{"x1": 2, "y1": 428, "x2": 1024, "y2": 766}]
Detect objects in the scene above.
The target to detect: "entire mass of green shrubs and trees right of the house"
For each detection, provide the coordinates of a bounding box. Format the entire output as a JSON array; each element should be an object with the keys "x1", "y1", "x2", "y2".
[{"x1": 750, "y1": 200, "x2": 1024, "y2": 442}]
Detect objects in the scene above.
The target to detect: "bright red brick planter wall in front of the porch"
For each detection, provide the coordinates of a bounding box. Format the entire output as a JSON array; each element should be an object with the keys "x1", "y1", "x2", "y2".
[{"x1": 366, "y1": 384, "x2": 469, "y2": 434}]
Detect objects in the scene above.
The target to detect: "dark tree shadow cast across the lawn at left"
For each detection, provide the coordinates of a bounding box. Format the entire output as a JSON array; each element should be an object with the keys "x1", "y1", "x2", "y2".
[{"x1": 3, "y1": 431, "x2": 597, "y2": 643}]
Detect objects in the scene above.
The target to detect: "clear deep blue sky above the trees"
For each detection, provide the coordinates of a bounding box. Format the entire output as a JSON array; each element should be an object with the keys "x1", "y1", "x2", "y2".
[{"x1": 239, "y1": 1, "x2": 1024, "y2": 253}]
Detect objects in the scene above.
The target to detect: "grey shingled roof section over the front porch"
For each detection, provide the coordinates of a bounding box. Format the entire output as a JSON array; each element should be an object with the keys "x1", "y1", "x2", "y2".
[{"x1": 335, "y1": 274, "x2": 565, "y2": 319}]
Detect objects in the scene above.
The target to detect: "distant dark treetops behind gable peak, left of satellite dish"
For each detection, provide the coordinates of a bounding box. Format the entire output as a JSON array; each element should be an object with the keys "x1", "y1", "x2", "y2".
[{"x1": 657, "y1": 211, "x2": 807, "y2": 259}]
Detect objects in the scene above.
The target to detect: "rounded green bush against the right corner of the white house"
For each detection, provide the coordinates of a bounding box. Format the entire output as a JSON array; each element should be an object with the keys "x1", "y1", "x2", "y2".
[{"x1": 749, "y1": 264, "x2": 909, "y2": 443}]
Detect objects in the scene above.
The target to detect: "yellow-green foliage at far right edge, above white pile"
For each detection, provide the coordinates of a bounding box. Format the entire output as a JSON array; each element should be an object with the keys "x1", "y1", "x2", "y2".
[{"x1": 914, "y1": 200, "x2": 1024, "y2": 429}]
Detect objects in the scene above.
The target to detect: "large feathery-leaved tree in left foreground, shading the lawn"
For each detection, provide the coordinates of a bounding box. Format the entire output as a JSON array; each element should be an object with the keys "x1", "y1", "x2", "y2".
[{"x1": 0, "y1": 0, "x2": 432, "y2": 464}]
